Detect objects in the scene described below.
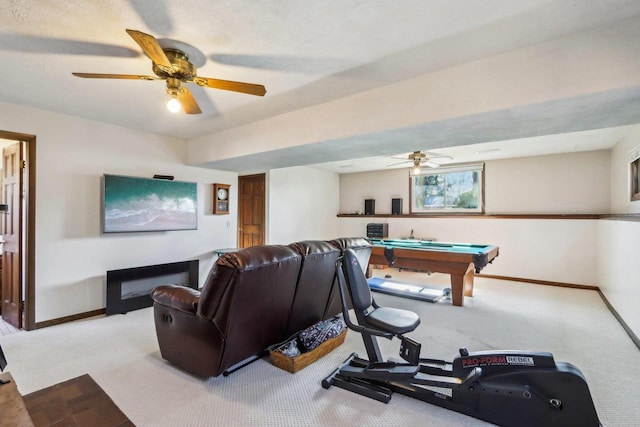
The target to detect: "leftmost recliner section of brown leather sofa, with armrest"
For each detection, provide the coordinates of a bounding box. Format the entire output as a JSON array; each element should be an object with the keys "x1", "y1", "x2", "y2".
[{"x1": 152, "y1": 245, "x2": 302, "y2": 376}]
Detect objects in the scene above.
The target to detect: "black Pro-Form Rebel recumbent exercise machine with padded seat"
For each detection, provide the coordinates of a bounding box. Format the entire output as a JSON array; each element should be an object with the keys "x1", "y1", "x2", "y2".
[{"x1": 322, "y1": 250, "x2": 600, "y2": 426}]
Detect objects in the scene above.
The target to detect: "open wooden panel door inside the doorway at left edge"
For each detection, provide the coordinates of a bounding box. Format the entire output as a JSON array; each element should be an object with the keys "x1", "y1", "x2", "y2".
[{"x1": 2, "y1": 142, "x2": 25, "y2": 329}]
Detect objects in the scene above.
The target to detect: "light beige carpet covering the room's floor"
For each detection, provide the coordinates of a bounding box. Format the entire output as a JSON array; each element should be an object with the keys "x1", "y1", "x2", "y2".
[{"x1": 0, "y1": 274, "x2": 640, "y2": 426}]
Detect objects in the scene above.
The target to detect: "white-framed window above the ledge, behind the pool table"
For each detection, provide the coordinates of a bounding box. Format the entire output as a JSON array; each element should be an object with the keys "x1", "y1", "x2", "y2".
[{"x1": 409, "y1": 164, "x2": 484, "y2": 213}]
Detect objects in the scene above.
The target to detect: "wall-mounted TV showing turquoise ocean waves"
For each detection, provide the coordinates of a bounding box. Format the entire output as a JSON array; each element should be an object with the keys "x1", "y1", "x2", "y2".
[{"x1": 102, "y1": 174, "x2": 198, "y2": 233}]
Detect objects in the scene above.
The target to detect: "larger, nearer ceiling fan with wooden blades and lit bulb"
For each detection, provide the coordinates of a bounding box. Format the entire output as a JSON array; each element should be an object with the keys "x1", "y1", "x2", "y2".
[{"x1": 72, "y1": 30, "x2": 267, "y2": 114}]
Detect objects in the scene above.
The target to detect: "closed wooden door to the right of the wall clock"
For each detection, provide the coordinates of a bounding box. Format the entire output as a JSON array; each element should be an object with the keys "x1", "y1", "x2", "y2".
[{"x1": 238, "y1": 174, "x2": 265, "y2": 248}]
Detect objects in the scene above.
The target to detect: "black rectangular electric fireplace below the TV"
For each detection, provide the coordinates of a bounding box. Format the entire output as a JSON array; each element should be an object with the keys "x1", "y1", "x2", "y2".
[{"x1": 107, "y1": 259, "x2": 198, "y2": 316}]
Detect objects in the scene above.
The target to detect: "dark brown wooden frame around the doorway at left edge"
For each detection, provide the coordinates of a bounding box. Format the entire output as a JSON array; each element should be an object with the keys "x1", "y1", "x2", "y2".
[{"x1": 0, "y1": 130, "x2": 36, "y2": 331}]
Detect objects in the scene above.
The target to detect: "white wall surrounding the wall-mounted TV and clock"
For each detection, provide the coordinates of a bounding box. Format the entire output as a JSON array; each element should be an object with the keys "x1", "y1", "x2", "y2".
[{"x1": 0, "y1": 103, "x2": 237, "y2": 322}]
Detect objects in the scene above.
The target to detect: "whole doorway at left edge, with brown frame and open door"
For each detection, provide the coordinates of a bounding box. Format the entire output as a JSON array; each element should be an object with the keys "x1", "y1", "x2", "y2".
[{"x1": 0, "y1": 130, "x2": 36, "y2": 330}]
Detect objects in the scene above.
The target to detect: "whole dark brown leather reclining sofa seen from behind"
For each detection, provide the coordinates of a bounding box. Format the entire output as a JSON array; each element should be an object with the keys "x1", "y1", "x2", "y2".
[{"x1": 152, "y1": 238, "x2": 371, "y2": 376}]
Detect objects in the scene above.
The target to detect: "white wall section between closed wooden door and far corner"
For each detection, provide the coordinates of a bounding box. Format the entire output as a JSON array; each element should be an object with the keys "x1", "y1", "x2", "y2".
[{"x1": 267, "y1": 166, "x2": 340, "y2": 244}]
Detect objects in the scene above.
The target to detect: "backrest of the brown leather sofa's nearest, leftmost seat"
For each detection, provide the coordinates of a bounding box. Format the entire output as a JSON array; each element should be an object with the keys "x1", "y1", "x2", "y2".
[{"x1": 198, "y1": 245, "x2": 302, "y2": 370}]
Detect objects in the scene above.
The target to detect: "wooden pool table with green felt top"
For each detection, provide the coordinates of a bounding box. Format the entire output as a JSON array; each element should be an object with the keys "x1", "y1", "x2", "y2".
[{"x1": 369, "y1": 239, "x2": 498, "y2": 306}]
